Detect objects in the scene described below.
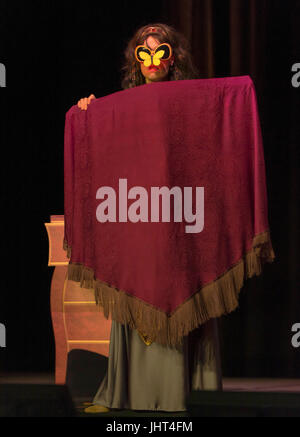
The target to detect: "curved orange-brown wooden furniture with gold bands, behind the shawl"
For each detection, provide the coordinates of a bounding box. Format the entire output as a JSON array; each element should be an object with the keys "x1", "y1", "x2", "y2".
[{"x1": 45, "y1": 215, "x2": 111, "y2": 384}]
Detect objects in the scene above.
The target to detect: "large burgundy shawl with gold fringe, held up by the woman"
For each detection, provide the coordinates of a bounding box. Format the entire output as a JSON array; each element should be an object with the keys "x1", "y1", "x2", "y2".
[{"x1": 64, "y1": 76, "x2": 275, "y2": 345}]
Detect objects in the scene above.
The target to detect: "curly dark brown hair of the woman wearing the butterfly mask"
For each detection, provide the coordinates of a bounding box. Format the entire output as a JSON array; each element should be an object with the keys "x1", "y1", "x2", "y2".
[{"x1": 121, "y1": 23, "x2": 199, "y2": 89}]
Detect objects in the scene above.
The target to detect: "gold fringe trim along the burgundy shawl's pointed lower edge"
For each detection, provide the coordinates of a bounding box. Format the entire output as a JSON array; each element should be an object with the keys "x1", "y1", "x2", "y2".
[{"x1": 63, "y1": 231, "x2": 275, "y2": 347}]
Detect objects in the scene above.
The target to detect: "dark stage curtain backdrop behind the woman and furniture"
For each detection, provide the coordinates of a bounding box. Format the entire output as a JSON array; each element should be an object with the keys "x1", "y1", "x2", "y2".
[{"x1": 0, "y1": 0, "x2": 300, "y2": 378}]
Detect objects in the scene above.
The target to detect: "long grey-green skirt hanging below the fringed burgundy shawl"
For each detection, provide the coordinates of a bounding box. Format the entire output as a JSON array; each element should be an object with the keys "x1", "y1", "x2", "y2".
[{"x1": 93, "y1": 319, "x2": 222, "y2": 412}]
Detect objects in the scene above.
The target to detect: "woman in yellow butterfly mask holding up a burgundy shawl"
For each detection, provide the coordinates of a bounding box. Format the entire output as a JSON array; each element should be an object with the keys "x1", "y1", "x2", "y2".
[{"x1": 78, "y1": 23, "x2": 222, "y2": 413}]
